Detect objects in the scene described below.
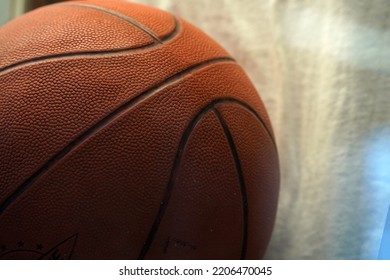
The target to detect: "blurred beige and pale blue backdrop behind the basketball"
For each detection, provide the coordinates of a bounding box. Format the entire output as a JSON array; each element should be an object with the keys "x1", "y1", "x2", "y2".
[{"x1": 0, "y1": 0, "x2": 390, "y2": 259}]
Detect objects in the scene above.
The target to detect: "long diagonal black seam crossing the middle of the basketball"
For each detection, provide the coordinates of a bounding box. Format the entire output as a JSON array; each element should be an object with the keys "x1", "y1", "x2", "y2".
[{"x1": 0, "y1": 57, "x2": 235, "y2": 216}]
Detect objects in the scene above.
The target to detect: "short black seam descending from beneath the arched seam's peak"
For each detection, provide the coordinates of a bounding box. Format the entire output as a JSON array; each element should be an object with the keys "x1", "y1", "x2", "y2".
[{"x1": 213, "y1": 108, "x2": 248, "y2": 260}]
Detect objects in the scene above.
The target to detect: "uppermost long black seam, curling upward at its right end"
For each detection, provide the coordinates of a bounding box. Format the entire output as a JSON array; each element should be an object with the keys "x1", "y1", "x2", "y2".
[{"x1": 0, "y1": 19, "x2": 180, "y2": 75}]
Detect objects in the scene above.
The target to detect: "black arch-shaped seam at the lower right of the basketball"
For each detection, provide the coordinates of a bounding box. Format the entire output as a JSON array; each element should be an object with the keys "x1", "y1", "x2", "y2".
[{"x1": 138, "y1": 98, "x2": 276, "y2": 260}]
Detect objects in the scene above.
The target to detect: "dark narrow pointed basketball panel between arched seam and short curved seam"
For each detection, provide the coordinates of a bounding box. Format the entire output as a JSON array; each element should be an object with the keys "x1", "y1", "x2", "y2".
[{"x1": 145, "y1": 108, "x2": 244, "y2": 259}]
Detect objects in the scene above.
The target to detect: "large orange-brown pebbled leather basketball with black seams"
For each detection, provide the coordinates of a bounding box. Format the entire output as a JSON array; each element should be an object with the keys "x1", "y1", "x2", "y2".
[{"x1": 0, "y1": 0, "x2": 279, "y2": 259}]
